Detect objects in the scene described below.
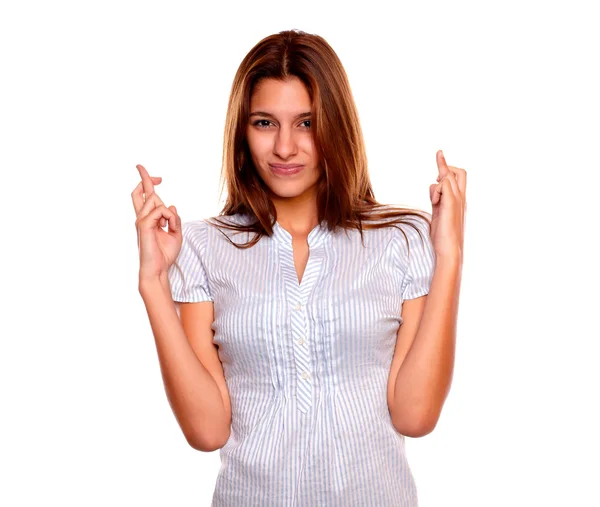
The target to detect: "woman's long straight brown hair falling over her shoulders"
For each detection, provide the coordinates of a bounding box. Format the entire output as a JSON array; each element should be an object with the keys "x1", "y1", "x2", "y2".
[{"x1": 213, "y1": 30, "x2": 431, "y2": 252}]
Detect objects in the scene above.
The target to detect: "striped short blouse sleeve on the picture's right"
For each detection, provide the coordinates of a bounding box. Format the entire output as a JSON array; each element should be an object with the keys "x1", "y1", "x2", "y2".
[{"x1": 399, "y1": 216, "x2": 435, "y2": 301}]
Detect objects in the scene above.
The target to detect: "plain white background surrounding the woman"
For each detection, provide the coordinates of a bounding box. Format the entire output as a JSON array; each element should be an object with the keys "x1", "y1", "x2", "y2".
[{"x1": 0, "y1": 0, "x2": 600, "y2": 507}]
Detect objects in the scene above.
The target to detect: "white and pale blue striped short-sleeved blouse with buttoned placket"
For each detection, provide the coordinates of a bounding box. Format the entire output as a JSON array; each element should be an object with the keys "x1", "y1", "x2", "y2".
[{"x1": 169, "y1": 212, "x2": 435, "y2": 507}]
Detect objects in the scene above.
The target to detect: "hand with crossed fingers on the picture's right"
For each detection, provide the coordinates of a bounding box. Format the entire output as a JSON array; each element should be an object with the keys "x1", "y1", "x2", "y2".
[{"x1": 429, "y1": 150, "x2": 467, "y2": 263}]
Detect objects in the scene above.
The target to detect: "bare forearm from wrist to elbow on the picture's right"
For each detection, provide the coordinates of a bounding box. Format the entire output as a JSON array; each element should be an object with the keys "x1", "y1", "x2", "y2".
[{"x1": 394, "y1": 258, "x2": 462, "y2": 435}]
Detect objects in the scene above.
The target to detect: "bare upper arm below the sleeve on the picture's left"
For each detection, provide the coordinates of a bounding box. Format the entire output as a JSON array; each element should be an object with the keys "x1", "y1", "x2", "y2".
[{"x1": 176, "y1": 301, "x2": 231, "y2": 446}]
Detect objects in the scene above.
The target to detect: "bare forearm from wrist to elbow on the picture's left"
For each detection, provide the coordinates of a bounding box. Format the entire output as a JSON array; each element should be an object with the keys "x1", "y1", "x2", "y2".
[{"x1": 139, "y1": 280, "x2": 227, "y2": 451}]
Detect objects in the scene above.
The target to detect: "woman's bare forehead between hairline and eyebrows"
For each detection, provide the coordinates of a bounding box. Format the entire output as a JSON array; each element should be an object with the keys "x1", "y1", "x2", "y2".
[{"x1": 250, "y1": 76, "x2": 311, "y2": 114}]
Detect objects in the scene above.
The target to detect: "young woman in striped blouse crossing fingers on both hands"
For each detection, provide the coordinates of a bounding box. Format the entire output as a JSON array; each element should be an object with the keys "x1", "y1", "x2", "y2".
[{"x1": 132, "y1": 31, "x2": 466, "y2": 507}]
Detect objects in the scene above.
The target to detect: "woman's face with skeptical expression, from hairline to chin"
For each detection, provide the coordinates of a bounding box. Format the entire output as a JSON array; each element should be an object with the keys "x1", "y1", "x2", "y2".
[{"x1": 246, "y1": 77, "x2": 321, "y2": 200}]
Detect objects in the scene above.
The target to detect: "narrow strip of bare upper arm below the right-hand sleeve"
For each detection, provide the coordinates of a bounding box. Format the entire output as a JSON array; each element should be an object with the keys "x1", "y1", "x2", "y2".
[{"x1": 387, "y1": 295, "x2": 427, "y2": 416}]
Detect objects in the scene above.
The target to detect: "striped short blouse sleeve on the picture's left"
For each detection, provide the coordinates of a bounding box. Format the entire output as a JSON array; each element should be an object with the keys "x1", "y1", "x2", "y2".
[{"x1": 168, "y1": 220, "x2": 213, "y2": 303}]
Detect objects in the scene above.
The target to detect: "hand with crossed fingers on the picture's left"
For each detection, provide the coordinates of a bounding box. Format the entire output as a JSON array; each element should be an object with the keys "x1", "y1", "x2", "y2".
[{"x1": 131, "y1": 165, "x2": 183, "y2": 280}]
